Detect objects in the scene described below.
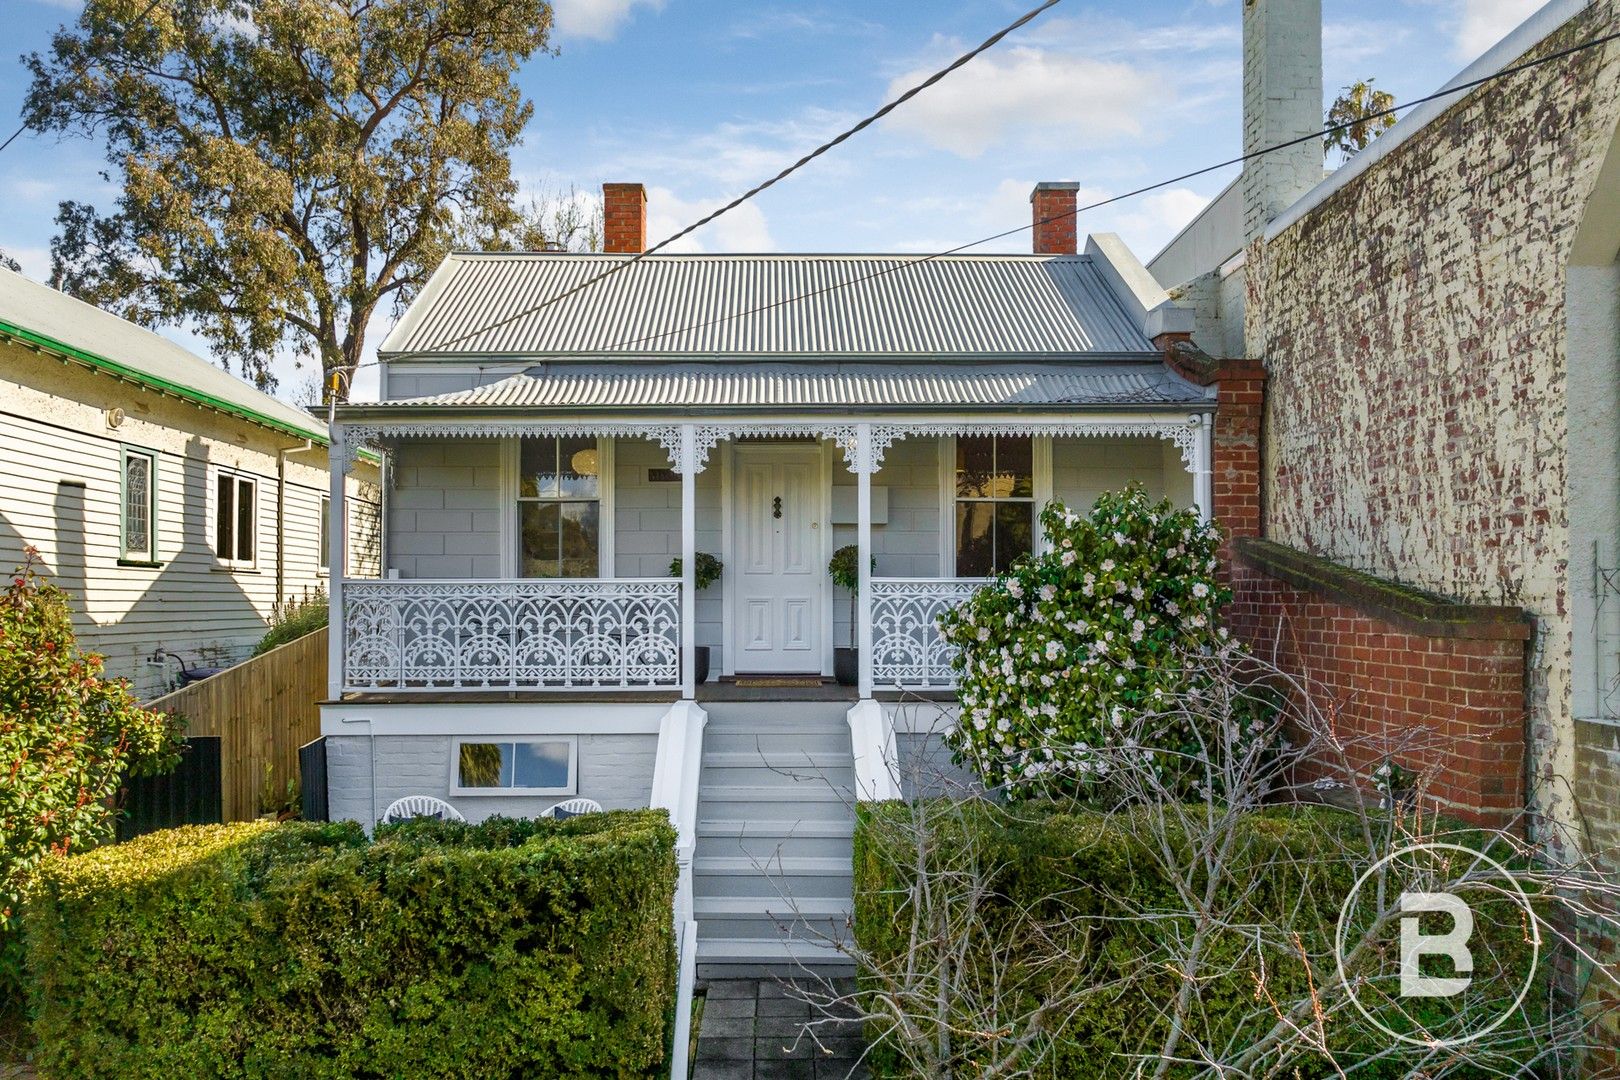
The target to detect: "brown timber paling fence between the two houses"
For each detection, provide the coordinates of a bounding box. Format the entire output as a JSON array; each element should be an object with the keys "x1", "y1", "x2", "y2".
[{"x1": 139, "y1": 627, "x2": 327, "y2": 827}]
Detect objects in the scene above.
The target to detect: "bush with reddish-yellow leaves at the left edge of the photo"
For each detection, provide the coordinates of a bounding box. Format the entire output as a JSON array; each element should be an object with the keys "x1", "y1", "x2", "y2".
[{"x1": 0, "y1": 549, "x2": 180, "y2": 991}]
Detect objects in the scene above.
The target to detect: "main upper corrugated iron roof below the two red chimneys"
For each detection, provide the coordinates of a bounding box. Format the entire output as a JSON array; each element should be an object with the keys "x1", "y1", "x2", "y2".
[{"x1": 379, "y1": 253, "x2": 1153, "y2": 356}]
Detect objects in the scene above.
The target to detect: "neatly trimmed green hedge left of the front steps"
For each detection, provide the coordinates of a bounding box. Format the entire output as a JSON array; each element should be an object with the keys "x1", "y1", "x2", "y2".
[{"x1": 26, "y1": 811, "x2": 676, "y2": 1078}]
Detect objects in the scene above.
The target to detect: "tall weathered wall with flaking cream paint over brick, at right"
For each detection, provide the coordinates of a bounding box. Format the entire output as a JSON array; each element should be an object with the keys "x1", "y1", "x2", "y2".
[{"x1": 1246, "y1": 0, "x2": 1620, "y2": 826}]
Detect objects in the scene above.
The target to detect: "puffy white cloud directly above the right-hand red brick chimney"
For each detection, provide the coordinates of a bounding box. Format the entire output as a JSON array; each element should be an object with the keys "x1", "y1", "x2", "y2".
[{"x1": 888, "y1": 45, "x2": 1173, "y2": 157}]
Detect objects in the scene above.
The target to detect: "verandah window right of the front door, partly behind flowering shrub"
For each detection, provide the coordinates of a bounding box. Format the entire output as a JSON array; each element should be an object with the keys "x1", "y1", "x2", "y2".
[{"x1": 956, "y1": 436, "x2": 1035, "y2": 578}]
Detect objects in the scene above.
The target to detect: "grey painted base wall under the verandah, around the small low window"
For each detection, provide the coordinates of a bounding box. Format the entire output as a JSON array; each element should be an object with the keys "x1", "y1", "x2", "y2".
[{"x1": 326, "y1": 735, "x2": 658, "y2": 823}]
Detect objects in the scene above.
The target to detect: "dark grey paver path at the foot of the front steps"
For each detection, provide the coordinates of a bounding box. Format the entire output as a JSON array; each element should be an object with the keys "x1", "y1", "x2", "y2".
[{"x1": 692, "y1": 978, "x2": 867, "y2": 1080}]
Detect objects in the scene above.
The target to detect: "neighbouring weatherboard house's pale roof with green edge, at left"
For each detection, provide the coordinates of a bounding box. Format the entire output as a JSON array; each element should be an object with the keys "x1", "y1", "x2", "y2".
[{"x1": 0, "y1": 269, "x2": 330, "y2": 445}]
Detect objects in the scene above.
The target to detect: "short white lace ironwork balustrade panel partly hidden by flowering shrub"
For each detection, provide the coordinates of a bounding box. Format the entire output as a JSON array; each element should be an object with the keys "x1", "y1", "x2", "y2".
[{"x1": 872, "y1": 578, "x2": 985, "y2": 690}]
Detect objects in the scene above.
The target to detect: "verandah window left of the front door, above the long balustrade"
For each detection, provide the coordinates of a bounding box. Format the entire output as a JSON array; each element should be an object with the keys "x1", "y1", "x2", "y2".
[{"x1": 518, "y1": 437, "x2": 601, "y2": 578}]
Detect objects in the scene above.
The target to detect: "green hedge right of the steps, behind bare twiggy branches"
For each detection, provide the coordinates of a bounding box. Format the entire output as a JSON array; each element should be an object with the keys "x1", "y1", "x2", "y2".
[{"x1": 854, "y1": 800, "x2": 1544, "y2": 1078}]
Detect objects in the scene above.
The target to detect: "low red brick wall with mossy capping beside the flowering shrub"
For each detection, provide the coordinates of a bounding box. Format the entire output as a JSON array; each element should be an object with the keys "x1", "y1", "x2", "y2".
[{"x1": 1230, "y1": 551, "x2": 1528, "y2": 824}]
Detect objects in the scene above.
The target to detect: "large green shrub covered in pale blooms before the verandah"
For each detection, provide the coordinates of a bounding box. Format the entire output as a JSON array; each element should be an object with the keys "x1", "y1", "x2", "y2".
[{"x1": 940, "y1": 484, "x2": 1231, "y2": 795}]
